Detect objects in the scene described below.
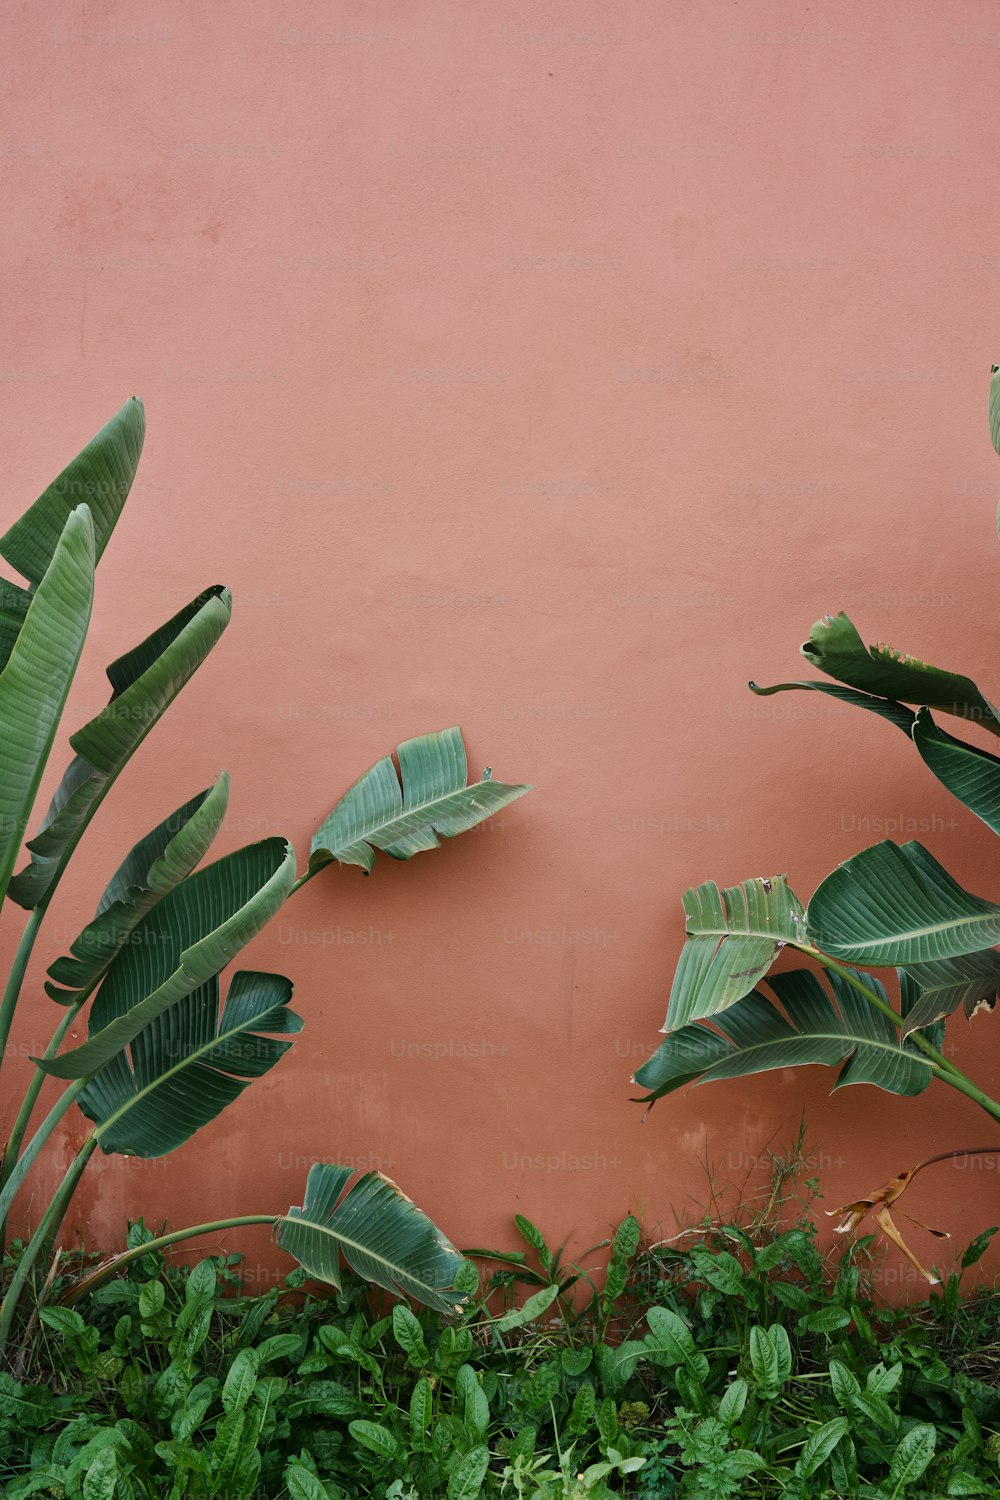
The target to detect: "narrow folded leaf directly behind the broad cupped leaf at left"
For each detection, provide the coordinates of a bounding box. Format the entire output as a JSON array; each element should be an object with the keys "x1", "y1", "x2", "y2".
[{"x1": 45, "y1": 771, "x2": 229, "y2": 1005}]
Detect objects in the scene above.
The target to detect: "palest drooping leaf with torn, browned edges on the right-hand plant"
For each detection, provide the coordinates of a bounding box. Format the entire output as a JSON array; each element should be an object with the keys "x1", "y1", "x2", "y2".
[{"x1": 664, "y1": 875, "x2": 804, "y2": 1031}]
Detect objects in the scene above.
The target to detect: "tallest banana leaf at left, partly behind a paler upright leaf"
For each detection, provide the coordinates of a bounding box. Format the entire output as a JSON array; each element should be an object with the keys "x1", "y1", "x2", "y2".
[{"x1": 0, "y1": 396, "x2": 145, "y2": 585}]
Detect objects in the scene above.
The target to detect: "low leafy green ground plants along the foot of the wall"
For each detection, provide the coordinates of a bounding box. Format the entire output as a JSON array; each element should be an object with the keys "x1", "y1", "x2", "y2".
[{"x1": 0, "y1": 1194, "x2": 1000, "y2": 1500}]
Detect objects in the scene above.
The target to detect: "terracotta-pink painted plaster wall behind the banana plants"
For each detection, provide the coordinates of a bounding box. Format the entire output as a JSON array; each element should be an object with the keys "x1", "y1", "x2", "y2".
[{"x1": 0, "y1": 0, "x2": 1000, "y2": 1287}]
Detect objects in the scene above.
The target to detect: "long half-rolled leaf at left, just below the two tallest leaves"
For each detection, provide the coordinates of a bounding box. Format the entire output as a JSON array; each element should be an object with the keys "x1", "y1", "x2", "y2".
[{"x1": 10, "y1": 587, "x2": 231, "y2": 908}]
